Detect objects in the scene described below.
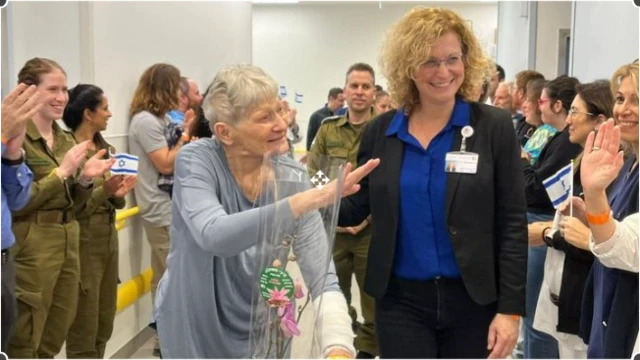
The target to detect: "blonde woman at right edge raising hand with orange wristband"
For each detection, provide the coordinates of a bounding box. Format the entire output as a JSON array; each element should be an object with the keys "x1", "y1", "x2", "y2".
[{"x1": 574, "y1": 63, "x2": 639, "y2": 359}]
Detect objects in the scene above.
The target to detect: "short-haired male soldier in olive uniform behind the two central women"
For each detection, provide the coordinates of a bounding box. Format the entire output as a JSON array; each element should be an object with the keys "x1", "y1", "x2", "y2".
[{"x1": 308, "y1": 63, "x2": 378, "y2": 358}]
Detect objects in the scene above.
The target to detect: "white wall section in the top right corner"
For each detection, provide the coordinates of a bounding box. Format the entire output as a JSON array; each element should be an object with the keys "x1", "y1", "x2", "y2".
[{"x1": 571, "y1": 1, "x2": 639, "y2": 82}]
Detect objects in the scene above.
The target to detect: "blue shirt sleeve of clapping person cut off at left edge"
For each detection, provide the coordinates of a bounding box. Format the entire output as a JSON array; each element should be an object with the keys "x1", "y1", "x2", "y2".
[{"x1": 2, "y1": 144, "x2": 33, "y2": 250}]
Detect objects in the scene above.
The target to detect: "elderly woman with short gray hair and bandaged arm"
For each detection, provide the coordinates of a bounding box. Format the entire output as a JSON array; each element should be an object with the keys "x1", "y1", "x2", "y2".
[{"x1": 154, "y1": 65, "x2": 379, "y2": 358}]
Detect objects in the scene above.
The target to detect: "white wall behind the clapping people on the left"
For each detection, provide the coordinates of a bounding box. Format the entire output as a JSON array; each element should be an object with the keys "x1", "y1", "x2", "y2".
[{"x1": 3, "y1": 1, "x2": 252, "y2": 357}]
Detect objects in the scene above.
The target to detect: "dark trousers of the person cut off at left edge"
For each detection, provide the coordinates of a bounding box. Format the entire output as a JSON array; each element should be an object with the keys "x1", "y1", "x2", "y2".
[{"x1": 0, "y1": 250, "x2": 18, "y2": 354}]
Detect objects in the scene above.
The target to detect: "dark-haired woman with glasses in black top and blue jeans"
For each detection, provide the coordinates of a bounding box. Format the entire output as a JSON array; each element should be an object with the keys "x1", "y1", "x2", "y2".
[{"x1": 522, "y1": 75, "x2": 582, "y2": 359}]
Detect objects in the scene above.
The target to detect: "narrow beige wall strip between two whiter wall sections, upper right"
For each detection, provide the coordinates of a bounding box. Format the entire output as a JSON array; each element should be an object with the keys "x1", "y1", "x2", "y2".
[{"x1": 535, "y1": 1, "x2": 571, "y2": 79}]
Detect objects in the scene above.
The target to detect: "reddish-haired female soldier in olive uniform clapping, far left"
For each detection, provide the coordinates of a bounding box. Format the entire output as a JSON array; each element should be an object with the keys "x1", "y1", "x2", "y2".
[{"x1": 8, "y1": 58, "x2": 113, "y2": 358}]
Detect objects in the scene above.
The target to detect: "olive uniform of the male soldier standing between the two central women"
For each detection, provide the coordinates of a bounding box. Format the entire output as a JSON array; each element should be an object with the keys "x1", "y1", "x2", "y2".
[{"x1": 308, "y1": 108, "x2": 378, "y2": 356}]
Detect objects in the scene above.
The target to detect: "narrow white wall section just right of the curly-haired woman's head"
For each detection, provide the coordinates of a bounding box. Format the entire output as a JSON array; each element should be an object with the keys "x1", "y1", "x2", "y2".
[{"x1": 496, "y1": 1, "x2": 535, "y2": 81}]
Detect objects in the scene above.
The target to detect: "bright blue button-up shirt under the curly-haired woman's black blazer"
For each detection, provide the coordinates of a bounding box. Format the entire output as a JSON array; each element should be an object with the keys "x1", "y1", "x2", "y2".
[{"x1": 386, "y1": 99, "x2": 471, "y2": 280}]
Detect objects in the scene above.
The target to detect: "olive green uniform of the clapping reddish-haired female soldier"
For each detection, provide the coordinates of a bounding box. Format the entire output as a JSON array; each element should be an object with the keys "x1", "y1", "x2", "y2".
[{"x1": 8, "y1": 121, "x2": 93, "y2": 358}]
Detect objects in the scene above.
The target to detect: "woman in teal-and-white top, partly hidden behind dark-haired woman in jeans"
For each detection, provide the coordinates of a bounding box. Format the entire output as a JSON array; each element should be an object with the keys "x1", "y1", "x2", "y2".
[{"x1": 521, "y1": 79, "x2": 558, "y2": 165}]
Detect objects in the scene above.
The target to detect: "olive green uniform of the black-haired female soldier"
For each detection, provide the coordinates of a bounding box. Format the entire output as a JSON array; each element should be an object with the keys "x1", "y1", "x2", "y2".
[{"x1": 66, "y1": 143, "x2": 125, "y2": 359}]
